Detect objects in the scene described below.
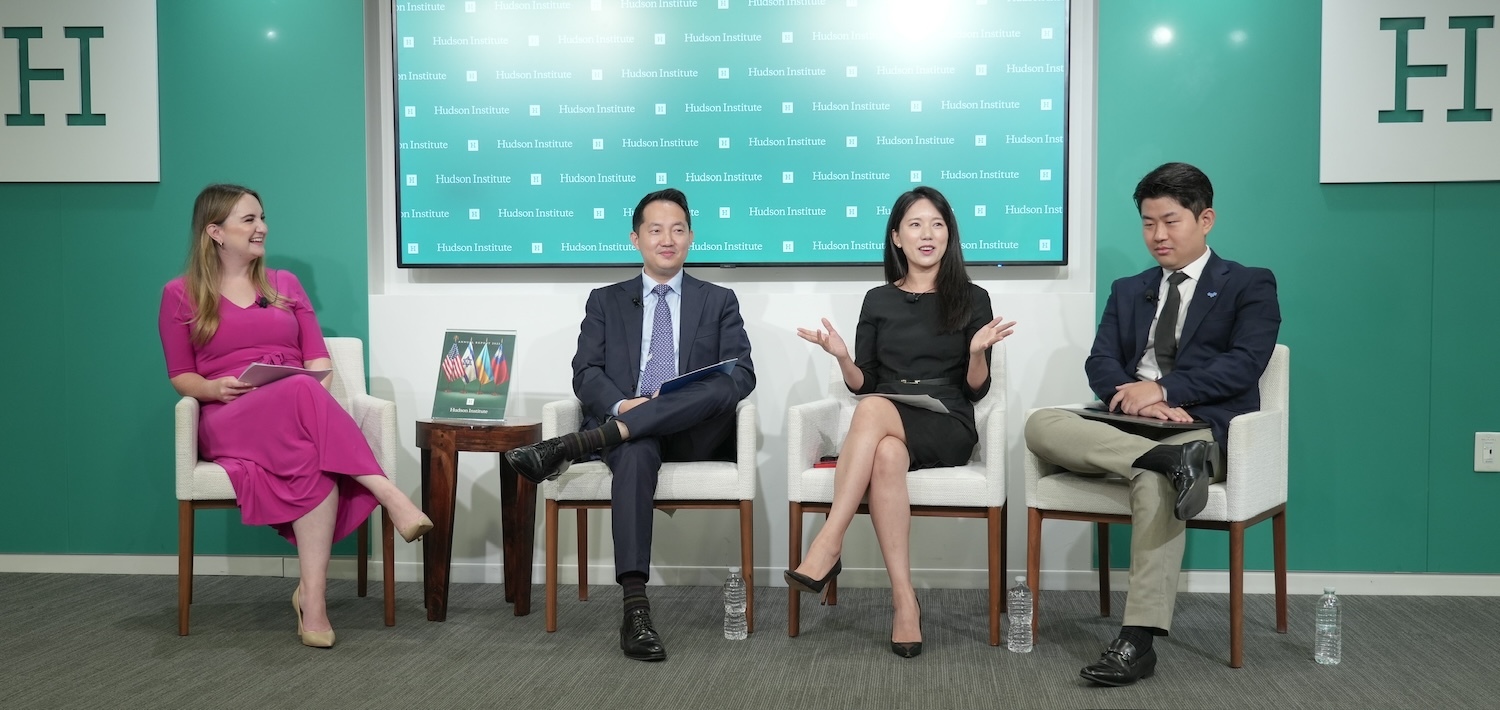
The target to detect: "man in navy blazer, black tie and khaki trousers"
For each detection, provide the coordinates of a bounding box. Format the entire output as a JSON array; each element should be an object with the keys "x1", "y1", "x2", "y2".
[{"x1": 1026, "y1": 162, "x2": 1281, "y2": 686}]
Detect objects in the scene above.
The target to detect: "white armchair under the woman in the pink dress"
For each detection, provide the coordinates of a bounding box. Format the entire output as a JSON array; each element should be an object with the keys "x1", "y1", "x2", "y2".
[{"x1": 176, "y1": 338, "x2": 396, "y2": 636}]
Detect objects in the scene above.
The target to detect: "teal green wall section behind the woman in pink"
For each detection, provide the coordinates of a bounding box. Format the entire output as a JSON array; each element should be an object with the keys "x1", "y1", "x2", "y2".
[{"x1": 0, "y1": 0, "x2": 369, "y2": 554}]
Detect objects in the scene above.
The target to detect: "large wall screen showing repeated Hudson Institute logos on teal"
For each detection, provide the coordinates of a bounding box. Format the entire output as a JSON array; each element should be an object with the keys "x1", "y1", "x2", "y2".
[{"x1": 393, "y1": 0, "x2": 1068, "y2": 267}]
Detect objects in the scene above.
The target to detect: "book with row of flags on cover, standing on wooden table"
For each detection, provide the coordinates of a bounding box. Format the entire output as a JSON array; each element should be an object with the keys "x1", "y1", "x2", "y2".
[{"x1": 432, "y1": 330, "x2": 516, "y2": 422}]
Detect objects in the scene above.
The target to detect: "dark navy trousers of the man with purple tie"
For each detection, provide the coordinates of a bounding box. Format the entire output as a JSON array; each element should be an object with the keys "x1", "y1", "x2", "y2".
[{"x1": 605, "y1": 375, "x2": 738, "y2": 579}]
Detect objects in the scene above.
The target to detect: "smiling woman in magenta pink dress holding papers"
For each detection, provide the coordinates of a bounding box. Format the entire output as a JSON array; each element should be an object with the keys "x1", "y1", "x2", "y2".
[{"x1": 158, "y1": 185, "x2": 432, "y2": 648}]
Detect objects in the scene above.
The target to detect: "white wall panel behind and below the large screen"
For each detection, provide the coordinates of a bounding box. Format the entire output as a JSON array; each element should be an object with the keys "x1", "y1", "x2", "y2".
[{"x1": 366, "y1": 0, "x2": 1095, "y2": 588}]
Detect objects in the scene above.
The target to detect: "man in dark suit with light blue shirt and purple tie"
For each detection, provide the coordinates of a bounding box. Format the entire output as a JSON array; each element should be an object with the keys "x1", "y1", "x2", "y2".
[{"x1": 506, "y1": 189, "x2": 755, "y2": 660}]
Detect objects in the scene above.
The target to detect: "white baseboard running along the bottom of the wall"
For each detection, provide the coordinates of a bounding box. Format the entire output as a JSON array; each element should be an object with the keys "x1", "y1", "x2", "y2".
[{"x1": 0, "y1": 554, "x2": 1500, "y2": 596}]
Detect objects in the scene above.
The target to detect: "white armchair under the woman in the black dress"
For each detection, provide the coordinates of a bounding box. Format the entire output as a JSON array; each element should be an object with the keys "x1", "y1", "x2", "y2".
[{"x1": 786, "y1": 345, "x2": 1005, "y2": 645}]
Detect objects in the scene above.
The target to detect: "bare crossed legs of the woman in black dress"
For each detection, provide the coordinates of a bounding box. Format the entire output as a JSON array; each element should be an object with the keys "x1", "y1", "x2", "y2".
[{"x1": 797, "y1": 398, "x2": 921, "y2": 641}]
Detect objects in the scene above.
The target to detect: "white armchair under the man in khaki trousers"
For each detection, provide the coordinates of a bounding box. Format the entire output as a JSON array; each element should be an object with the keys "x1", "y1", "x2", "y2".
[{"x1": 1026, "y1": 345, "x2": 1292, "y2": 668}]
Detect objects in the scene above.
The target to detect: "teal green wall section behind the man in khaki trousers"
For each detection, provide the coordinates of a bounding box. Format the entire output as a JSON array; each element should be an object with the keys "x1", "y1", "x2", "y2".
[{"x1": 1098, "y1": 0, "x2": 1500, "y2": 573}]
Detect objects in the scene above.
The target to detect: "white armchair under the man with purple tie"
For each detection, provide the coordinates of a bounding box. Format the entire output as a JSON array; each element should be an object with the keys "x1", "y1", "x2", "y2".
[{"x1": 542, "y1": 399, "x2": 759, "y2": 633}]
